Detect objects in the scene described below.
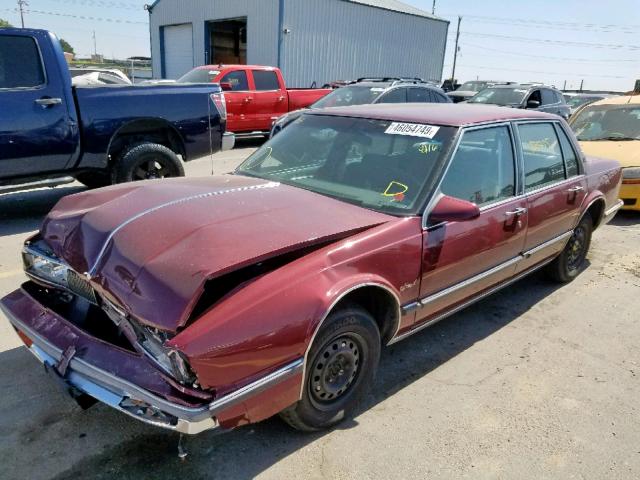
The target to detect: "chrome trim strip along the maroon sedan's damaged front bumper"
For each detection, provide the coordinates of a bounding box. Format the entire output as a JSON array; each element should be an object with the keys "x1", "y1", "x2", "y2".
[{"x1": 0, "y1": 304, "x2": 303, "y2": 434}]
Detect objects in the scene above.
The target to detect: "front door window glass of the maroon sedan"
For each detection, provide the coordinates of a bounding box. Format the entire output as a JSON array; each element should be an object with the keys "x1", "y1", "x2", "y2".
[{"x1": 440, "y1": 126, "x2": 516, "y2": 206}]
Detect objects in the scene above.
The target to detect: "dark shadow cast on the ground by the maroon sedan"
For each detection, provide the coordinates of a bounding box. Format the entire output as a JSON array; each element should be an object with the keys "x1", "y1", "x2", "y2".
[{"x1": 0, "y1": 274, "x2": 558, "y2": 480}]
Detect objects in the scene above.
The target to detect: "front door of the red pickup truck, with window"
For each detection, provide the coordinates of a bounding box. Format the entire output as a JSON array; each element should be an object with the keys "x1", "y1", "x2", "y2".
[{"x1": 218, "y1": 69, "x2": 253, "y2": 132}]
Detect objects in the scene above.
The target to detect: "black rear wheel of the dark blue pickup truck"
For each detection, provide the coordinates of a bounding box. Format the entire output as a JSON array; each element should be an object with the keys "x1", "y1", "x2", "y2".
[{"x1": 112, "y1": 143, "x2": 184, "y2": 183}]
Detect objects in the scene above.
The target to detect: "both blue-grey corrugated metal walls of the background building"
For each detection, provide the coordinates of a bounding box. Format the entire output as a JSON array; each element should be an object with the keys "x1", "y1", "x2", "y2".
[{"x1": 150, "y1": 0, "x2": 449, "y2": 87}]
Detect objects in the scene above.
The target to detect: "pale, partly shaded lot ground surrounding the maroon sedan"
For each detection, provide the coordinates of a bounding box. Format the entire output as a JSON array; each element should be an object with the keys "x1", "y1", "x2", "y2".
[{"x1": 0, "y1": 141, "x2": 640, "y2": 480}]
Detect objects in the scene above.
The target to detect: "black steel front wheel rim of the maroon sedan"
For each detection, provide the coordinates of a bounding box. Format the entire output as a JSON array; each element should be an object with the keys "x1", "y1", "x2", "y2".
[{"x1": 307, "y1": 333, "x2": 364, "y2": 409}]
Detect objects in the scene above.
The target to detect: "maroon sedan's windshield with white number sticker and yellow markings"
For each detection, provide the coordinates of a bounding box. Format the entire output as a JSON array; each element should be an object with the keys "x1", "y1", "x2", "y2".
[{"x1": 235, "y1": 114, "x2": 456, "y2": 215}]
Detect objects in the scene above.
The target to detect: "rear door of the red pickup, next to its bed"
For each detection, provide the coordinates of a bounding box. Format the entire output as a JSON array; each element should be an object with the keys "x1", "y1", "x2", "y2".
[{"x1": 251, "y1": 70, "x2": 288, "y2": 131}]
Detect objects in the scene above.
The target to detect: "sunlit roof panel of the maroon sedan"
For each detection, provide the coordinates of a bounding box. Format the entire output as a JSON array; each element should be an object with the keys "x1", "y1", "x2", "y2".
[{"x1": 309, "y1": 103, "x2": 558, "y2": 127}]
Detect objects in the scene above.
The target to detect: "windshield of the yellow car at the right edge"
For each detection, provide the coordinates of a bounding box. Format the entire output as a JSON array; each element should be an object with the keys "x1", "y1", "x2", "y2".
[{"x1": 571, "y1": 105, "x2": 640, "y2": 141}]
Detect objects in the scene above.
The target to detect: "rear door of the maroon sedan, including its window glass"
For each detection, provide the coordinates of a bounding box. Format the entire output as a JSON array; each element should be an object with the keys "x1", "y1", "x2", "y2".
[{"x1": 516, "y1": 121, "x2": 586, "y2": 271}]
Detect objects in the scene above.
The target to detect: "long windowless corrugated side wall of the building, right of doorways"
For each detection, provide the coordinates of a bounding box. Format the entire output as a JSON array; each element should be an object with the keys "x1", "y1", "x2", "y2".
[{"x1": 282, "y1": 0, "x2": 448, "y2": 86}]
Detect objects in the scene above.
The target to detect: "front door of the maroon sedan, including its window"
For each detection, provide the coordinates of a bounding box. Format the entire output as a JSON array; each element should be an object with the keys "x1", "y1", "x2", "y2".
[{"x1": 416, "y1": 123, "x2": 528, "y2": 322}]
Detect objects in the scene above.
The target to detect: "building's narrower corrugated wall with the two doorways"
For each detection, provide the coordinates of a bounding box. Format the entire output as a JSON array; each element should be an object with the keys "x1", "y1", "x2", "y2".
[{"x1": 149, "y1": 0, "x2": 278, "y2": 78}]
